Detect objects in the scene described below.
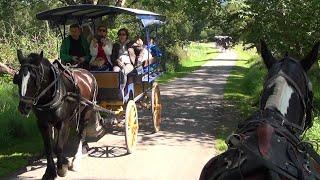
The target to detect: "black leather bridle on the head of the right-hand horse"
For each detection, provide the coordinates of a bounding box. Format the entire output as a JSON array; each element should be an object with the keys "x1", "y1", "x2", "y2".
[{"x1": 260, "y1": 57, "x2": 313, "y2": 132}]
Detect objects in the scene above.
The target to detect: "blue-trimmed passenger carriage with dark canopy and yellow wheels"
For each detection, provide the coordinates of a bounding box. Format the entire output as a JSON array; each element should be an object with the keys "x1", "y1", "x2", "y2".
[{"x1": 37, "y1": 5, "x2": 163, "y2": 153}]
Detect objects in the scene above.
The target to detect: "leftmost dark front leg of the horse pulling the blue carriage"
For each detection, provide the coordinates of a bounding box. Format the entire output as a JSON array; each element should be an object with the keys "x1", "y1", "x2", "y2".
[{"x1": 37, "y1": 120, "x2": 57, "y2": 179}]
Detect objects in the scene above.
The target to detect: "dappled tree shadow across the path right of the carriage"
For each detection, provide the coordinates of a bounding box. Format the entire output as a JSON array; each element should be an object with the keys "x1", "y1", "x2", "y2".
[{"x1": 139, "y1": 64, "x2": 245, "y2": 147}]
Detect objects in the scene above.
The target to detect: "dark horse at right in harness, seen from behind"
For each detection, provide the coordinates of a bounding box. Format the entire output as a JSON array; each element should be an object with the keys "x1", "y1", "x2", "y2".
[{"x1": 200, "y1": 41, "x2": 320, "y2": 180}]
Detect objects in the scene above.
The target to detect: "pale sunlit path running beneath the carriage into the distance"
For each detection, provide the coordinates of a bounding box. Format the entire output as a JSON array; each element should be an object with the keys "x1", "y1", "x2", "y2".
[{"x1": 12, "y1": 48, "x2": 236, "y2": 180}]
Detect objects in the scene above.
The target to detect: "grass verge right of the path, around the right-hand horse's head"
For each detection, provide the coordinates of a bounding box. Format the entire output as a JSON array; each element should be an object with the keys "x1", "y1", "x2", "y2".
[{"x1": 216, "y1": 46, "x2": 320, "y2": 152}]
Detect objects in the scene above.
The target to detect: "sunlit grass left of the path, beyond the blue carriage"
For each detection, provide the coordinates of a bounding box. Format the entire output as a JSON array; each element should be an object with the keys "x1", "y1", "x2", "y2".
[{"x1": 157, "y1": 42, "x2": 218, "y2": 84}]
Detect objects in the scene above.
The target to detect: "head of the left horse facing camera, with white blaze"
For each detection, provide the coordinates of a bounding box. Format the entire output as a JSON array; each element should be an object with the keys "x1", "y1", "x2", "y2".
[{"x1": 13, "y1": 50, "x2": 50, "y2": 115}]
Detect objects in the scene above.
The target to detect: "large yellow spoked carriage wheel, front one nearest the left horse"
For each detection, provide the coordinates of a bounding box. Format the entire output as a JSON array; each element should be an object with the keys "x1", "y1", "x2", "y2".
[{"x1": 125, "y1": 100, "x2": 139, "y2": 154}]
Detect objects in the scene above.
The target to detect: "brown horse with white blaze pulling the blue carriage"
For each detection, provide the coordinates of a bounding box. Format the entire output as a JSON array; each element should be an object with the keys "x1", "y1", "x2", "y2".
[{"x1": 13, "y1": 51, "x2": 97, "y2": 179}]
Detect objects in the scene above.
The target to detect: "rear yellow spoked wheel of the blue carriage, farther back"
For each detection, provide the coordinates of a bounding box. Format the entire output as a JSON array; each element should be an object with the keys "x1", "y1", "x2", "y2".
[{"x1": 151, "y1": 83, "x2": 162, "y2": 132}]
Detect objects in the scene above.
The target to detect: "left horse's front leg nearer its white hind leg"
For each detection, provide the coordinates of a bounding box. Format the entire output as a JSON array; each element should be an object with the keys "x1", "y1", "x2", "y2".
[{"x1": 54, "y1": 122, "x2": 69, "y2": 177}]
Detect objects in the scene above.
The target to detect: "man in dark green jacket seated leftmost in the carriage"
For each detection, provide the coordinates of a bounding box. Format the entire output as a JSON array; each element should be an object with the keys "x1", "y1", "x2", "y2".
[{"x1": 60, "y1": 24, "x2": 90, "y2": 69}]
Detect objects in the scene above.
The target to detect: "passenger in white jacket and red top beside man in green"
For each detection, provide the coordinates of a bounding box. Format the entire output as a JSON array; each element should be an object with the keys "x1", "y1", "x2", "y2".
[{"x1": 90, "y1": 25, "x2": 112, "y2": 71}]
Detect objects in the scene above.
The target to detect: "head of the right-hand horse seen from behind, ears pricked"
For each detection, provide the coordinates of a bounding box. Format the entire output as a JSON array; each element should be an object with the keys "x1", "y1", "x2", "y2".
[{"x1": 260, "y1": 40, "x2": 320, "y2": 132}]
